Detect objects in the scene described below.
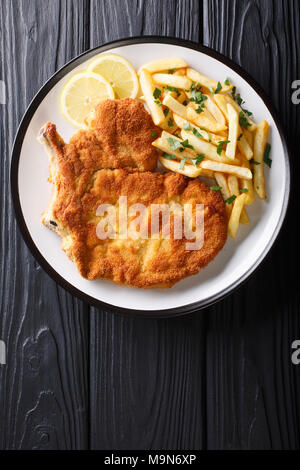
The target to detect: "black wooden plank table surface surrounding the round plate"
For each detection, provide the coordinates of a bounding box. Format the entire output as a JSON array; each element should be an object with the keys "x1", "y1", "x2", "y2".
[{"x1": 0, "y1": 0, "x2": 300, "y2": 450}]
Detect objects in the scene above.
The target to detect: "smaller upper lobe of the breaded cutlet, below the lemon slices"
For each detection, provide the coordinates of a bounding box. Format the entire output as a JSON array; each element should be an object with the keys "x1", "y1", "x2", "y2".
[{"x1": 69, "y1": 98, "x2": 160, "y2": 171}]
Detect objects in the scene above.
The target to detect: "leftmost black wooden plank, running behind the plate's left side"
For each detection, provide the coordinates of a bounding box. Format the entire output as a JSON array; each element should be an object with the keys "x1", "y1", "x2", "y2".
[{"x1": 0, "y1": 0, "x2": 89, "y2": 449}]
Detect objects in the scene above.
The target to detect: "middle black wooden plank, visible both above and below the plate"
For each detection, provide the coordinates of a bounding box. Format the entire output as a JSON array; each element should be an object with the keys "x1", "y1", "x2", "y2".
[{"x1": 90, "y1": 0, "x2": 205, "y2": 450}]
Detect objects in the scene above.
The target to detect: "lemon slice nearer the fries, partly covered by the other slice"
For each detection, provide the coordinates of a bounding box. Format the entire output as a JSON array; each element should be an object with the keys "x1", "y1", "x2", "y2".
[{"x1": 88, "y1": 54, "x2": 139, "y2": 99}]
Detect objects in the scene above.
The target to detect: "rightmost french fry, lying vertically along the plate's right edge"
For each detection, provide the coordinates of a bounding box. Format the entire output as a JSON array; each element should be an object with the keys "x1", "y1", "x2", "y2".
[{"x1": 253, "y1": 121, "x2": 269, "y2": 199}]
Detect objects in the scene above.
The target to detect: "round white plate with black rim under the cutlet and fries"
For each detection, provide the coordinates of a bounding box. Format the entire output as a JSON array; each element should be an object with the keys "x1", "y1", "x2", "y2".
[{"x1": 11, "y1": 37, "x2": 290, "y2": 316}]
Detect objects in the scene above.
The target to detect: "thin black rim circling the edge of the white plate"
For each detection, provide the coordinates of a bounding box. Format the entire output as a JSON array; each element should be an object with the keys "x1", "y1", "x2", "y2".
[{"x1": 10, "y1": 36, "x2": 290, "y2": 318}]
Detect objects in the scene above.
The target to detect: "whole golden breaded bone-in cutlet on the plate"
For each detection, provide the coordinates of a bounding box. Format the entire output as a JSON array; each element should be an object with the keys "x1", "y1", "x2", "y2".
[{"x1": 39, "y1": 99, "x2": 227, "y2": 288}]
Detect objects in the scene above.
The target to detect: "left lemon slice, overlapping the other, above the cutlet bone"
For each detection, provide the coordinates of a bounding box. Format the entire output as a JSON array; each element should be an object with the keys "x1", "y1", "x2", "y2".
[{"x1": 60, "y1": 71, "x2": 115, "y2": 127}]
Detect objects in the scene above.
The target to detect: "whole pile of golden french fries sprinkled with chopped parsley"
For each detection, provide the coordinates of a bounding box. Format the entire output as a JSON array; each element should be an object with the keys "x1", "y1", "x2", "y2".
[{"x1": 138, "y1": 58, "x2": 270, "y2": 238}]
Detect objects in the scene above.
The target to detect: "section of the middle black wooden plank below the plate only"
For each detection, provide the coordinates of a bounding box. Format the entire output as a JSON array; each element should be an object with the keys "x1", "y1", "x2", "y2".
[{"x1": 91, "y1": 310, "x2": 205, "y2": 450}]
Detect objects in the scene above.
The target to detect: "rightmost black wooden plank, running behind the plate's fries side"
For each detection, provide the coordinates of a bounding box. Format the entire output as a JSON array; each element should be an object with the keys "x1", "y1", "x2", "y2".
[{"x1": 203, "y1": 0, "x2": 300, "y2": 449}]
